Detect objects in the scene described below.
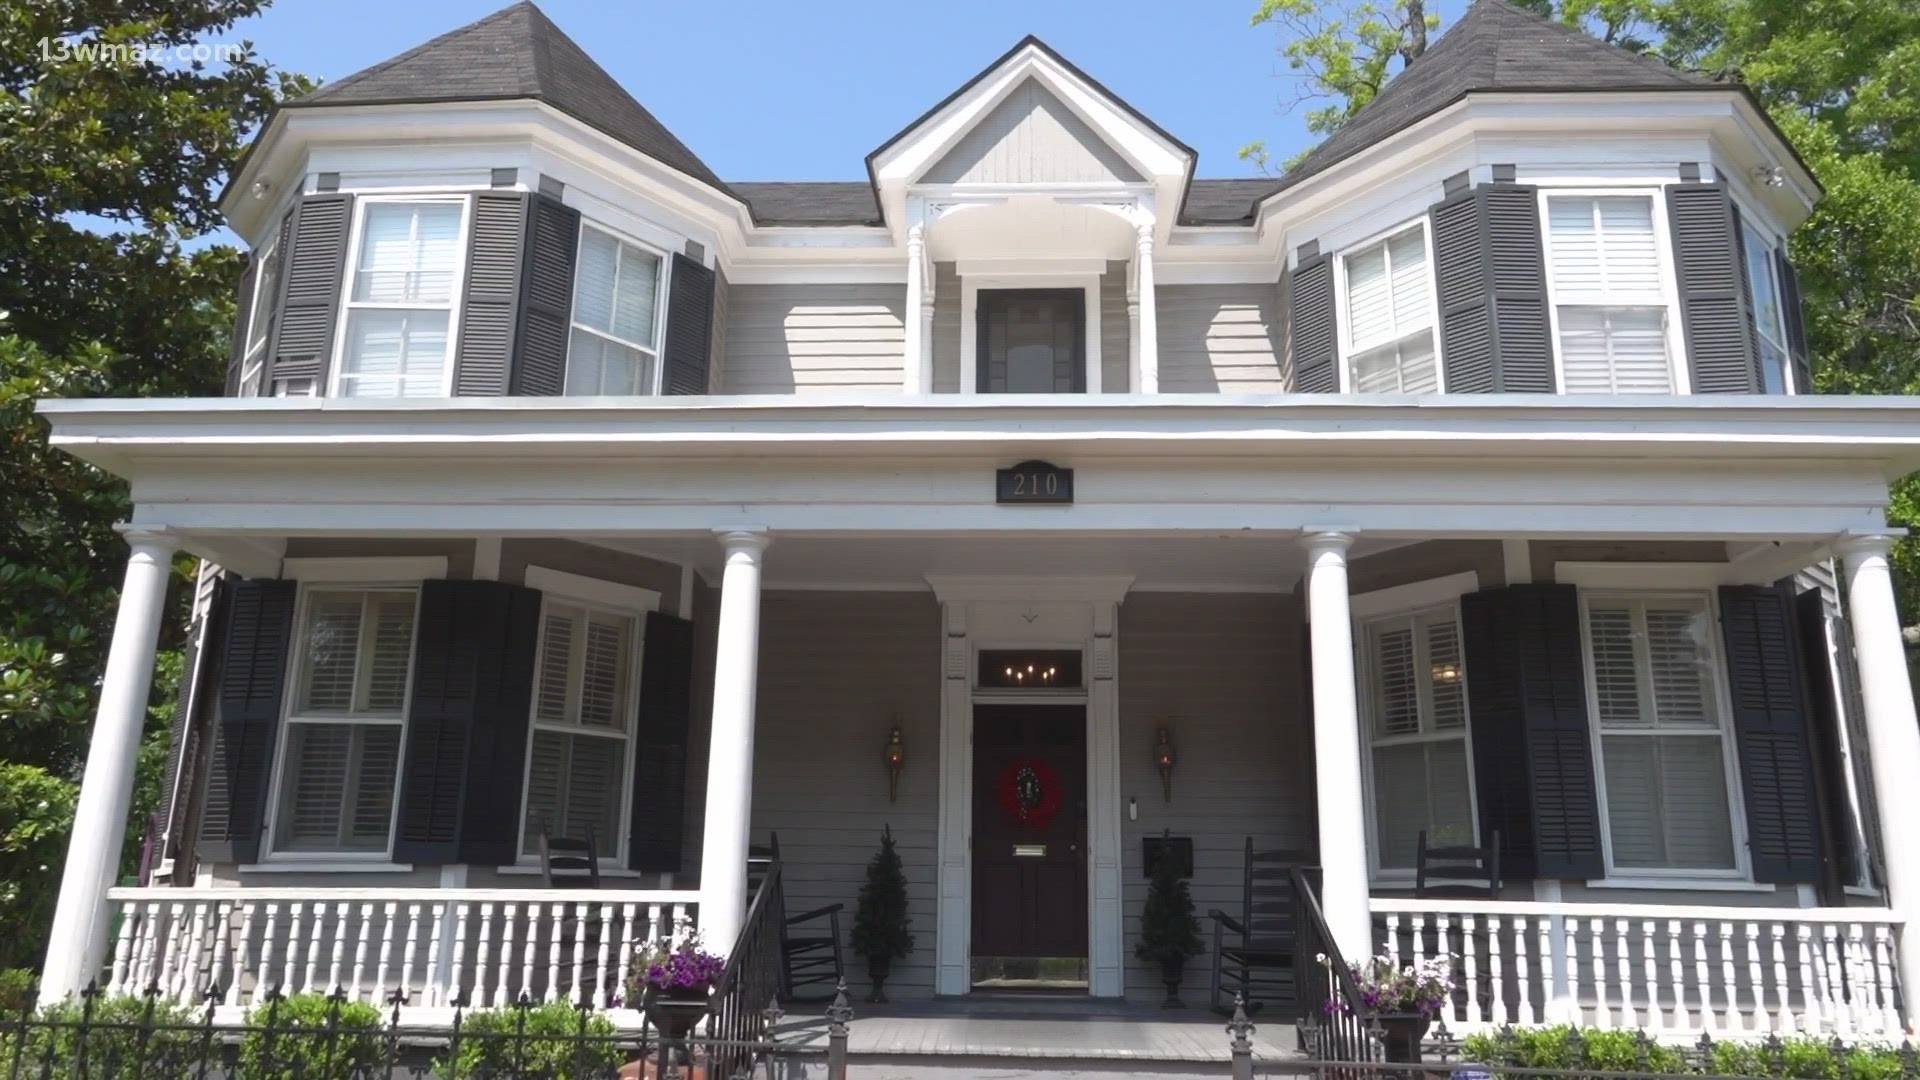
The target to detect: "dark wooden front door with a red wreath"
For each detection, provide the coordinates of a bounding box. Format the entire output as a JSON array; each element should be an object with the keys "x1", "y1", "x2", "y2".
[{"x1": 973, "y1": 705, "x2": 1087, "y2": 957}]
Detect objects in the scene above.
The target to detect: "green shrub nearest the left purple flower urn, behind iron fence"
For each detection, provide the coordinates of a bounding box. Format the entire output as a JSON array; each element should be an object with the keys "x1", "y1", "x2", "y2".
[{"x1": 434, "y1": 1001, "x2": 626, "y2": 1080}]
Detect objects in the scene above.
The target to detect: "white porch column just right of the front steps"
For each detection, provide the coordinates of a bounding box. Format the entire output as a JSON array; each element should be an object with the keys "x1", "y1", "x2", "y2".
[{"x1": 1304, "y1": 532, "x2": 1373, "y2": 963}]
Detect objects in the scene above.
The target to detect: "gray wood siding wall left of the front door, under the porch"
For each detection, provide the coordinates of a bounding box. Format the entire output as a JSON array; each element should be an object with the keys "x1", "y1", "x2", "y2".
[{"x1": 744, "y1": 592, "x2": 941, "y2": 1001}]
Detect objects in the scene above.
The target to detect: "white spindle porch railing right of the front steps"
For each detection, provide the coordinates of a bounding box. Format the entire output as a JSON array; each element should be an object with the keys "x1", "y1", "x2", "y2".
[{"x1": 1371, "y1": 897, "x2": 1901, "y2": 1038}]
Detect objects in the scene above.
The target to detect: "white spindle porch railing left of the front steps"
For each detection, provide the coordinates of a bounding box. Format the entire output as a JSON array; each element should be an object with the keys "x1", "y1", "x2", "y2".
[{"x1": 106, "y1": 888, "x2": 699, "y2": 1007}]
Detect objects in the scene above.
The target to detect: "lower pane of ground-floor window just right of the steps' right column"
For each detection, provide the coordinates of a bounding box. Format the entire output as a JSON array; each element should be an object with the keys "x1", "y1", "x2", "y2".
[{"x1": 1373, "y1": 738, "x2": 1473, "y2": 869}]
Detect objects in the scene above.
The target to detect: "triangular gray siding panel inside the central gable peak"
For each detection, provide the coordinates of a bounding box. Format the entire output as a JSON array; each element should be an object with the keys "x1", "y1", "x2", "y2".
[{"x1": 920, "y1": 79, "x2": 1140, "y2": 184}]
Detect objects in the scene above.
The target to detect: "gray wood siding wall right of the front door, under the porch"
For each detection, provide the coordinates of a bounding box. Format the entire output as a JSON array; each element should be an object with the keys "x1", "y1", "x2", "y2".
[{"x1": 1119, "y1": 592, "x2": 1315, "y2": 1005}]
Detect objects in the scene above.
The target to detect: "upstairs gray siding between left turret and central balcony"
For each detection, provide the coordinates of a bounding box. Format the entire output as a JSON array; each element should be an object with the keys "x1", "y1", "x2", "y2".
[{"x1": 722, "y1": 282, "x2": 906, "y2": 394}]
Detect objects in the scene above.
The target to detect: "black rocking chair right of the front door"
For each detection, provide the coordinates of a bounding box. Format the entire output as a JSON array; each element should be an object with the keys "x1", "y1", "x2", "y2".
[{"x1": 1208, "y1": 836, "x2": 1319, "y2": 1015}]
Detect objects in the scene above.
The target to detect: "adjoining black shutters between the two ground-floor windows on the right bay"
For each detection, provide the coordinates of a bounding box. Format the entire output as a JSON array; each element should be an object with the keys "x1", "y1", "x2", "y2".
[{"x1": 1461, "y1": 584, "x2": 1605, "y2": 878}]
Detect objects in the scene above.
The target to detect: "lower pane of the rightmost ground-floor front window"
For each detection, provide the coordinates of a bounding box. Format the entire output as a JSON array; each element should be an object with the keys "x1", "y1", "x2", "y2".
[{"x1": 1601, "y1": 734, "x2": 1734, "y2": 871}]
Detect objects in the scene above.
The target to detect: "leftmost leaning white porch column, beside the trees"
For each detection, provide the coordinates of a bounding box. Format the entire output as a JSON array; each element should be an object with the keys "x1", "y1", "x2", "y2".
[{"x1": 40, "y1": 530, "x2": 180, "y2": 1001}]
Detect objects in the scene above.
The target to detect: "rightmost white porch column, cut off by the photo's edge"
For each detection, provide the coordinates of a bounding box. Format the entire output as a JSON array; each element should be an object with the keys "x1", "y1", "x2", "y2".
[{"x1": 1839, "y1": 536, "x2": 1920, "y2": 1026}]
